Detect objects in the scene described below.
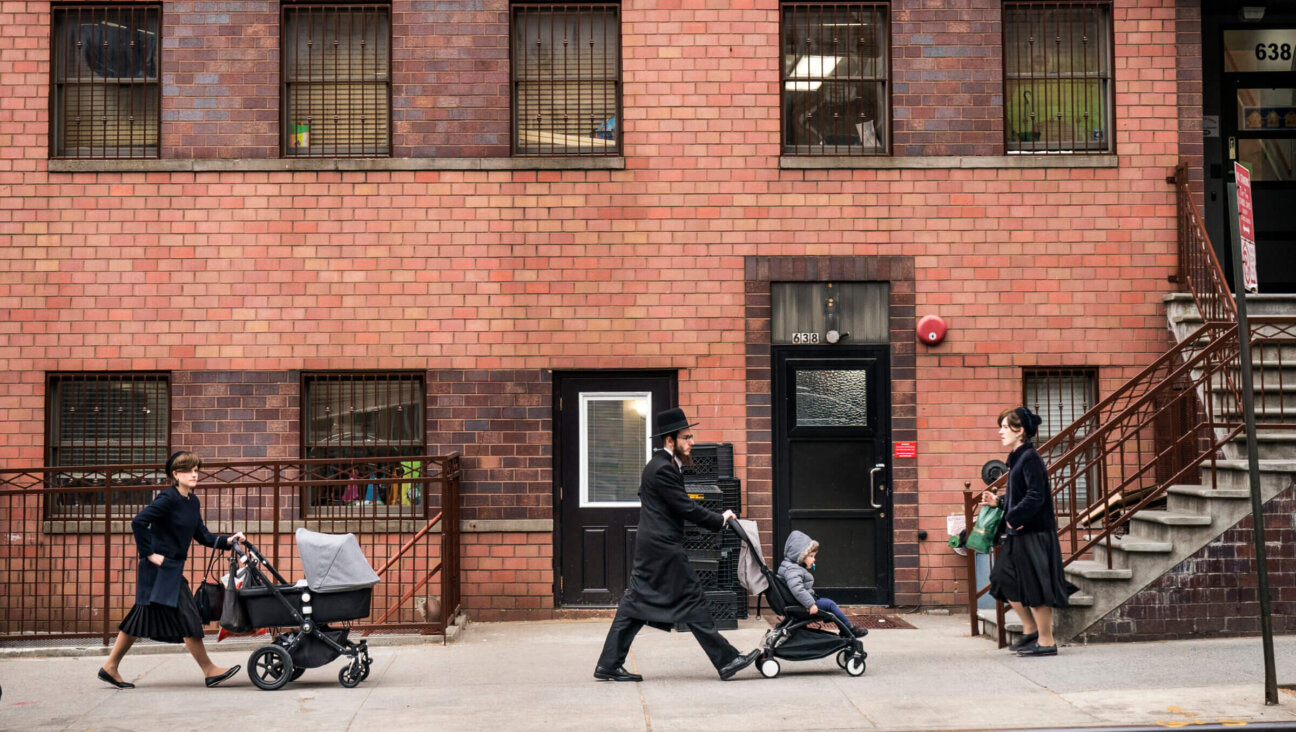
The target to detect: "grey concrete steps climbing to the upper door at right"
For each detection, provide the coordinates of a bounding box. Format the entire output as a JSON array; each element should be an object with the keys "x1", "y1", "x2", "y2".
[{"x1": 977, "y1": 294, "x2": 1296, "y2": 643}]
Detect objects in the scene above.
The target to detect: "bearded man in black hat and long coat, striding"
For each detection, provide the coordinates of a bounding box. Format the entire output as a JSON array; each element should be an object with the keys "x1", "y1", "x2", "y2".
[{"x1": 594, "y1": 408, "x2": 761, "y2": 681}]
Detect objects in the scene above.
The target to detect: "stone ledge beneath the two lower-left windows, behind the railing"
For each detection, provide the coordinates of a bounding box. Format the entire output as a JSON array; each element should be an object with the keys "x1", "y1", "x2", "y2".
[{"x1": 41, "y1": 516, "x2": 553, "y2": 536}]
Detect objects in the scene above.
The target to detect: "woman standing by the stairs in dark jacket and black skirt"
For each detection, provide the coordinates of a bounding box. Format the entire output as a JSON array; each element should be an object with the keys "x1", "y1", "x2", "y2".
[{"x1": 981, "y1": 407, "x2": 1077, "y2": 656}]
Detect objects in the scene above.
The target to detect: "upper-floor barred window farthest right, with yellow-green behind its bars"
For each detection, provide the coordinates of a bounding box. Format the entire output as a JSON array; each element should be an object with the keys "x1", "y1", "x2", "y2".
[{"x1": 1003, "y1": 1, "x2": 1115, "y2": 153}]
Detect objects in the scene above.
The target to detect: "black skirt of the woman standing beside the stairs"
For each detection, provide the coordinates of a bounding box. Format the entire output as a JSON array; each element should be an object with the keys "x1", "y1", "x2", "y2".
[{"x1": 990, "y1": 531, "x2": 1080, "y2": 608}]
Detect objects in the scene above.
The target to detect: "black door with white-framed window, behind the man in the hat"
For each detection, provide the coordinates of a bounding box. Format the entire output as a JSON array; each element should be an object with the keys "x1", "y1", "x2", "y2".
[{"x1": 553, "y1": 372, "x2": 675, "y2": 605}]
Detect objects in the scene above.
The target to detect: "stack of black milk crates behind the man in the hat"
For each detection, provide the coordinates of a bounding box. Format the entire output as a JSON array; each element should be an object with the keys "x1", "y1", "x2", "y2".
[{"x1": 678, "y1": 442, "x2": 746, "y2": 630}]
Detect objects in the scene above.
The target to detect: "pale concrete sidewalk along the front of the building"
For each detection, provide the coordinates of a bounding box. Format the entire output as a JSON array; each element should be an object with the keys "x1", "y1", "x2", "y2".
[{"x1": 0, "y1": 615, "x2": 1296, "y2": 732}]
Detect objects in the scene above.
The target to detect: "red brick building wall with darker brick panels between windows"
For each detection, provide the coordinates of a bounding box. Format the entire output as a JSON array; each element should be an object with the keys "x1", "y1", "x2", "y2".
[{"x1": 0, "y1": 0, "x2": 1200, "y2": 618}]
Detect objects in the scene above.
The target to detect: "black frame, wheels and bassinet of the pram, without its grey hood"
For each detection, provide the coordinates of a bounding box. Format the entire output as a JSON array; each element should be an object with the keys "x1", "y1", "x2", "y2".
[{"x1": 233, "y1": 540, "x2": 373, "y2": 691}]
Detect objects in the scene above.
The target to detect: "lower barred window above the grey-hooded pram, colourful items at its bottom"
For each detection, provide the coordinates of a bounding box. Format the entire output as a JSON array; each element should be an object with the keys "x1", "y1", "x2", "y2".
[{"x1": 302, "y1": 372, "x2": 426, "y2": 507}]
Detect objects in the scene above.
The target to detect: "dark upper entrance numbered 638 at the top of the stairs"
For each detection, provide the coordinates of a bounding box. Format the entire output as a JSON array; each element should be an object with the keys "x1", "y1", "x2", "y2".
[{"x1": 1204, "y1": 16, "x2": 1296, "y2": 293}]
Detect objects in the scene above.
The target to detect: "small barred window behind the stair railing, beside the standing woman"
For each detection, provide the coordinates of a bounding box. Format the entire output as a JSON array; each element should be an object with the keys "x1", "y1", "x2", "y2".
[{"x1": 1021, "y1": 368, "x2": 1098, "y2": 512}]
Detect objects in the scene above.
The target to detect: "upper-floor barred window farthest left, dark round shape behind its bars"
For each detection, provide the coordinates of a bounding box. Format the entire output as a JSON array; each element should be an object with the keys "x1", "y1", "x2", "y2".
[{"x1": 49, "y1": 5, "x2": 162, "y2": 158}]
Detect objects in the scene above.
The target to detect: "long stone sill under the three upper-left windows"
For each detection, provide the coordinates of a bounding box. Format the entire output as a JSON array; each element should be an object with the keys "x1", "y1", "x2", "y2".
[{"x1": 49, "y1": 157, "x2": 626, "y2": 172}]
